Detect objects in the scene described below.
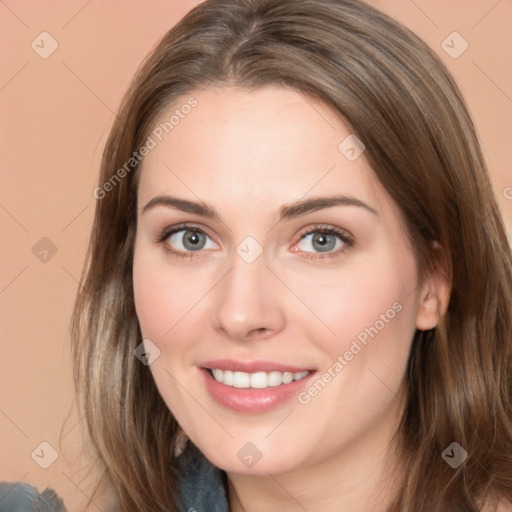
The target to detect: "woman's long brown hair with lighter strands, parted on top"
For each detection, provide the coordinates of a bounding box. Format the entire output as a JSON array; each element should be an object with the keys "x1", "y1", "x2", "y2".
[{"x1": 72, "y1": 0, "x2": 512, "y2": 512}]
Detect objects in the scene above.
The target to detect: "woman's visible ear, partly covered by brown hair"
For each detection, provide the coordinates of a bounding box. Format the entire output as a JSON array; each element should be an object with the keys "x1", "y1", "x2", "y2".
[{"x1": 416, "y1": 242, "x2": 451, "y2": 331}]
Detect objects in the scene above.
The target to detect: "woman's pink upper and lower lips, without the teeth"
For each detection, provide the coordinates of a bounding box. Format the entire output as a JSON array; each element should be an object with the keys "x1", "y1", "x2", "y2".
[{"x1": 198, "y1": 359, "x2": 317, "y2": 414}]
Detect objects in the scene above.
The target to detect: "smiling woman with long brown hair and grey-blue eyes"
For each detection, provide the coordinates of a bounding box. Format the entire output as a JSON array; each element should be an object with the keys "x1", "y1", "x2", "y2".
[{"x1": 3, "y1": 0, "x2": 512, "y2": 512}]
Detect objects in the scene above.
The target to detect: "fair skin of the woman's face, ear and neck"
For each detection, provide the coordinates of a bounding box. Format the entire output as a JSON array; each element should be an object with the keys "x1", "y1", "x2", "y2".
[{"x1": 133, "y1": 87, "x2": 449, "y2": 512}]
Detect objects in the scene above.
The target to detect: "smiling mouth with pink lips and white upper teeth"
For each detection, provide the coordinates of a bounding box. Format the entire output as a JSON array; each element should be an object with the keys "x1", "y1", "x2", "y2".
[{"x1": 198, "y1": 360, "x2": 316, "y2": 413}]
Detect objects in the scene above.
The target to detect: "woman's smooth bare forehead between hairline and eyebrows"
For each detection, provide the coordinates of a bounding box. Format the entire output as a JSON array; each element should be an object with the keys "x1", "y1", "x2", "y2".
[{"x1": 138, "y1": 86, "x2": 385, "y2": 216}]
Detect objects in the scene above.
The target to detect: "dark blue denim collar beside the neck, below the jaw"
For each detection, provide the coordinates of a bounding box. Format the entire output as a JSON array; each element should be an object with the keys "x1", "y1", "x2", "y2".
[{"x1": 172, "y1": 441, "x2": 229, "y2": 512}]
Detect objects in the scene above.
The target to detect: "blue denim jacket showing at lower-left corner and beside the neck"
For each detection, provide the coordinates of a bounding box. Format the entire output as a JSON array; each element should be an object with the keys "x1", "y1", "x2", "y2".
[{"x1": 0, "y1": 442, "x2": 229, "y2": 512}]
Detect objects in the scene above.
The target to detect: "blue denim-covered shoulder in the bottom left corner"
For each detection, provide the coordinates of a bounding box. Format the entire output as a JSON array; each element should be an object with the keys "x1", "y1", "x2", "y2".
[{"x1": 0, "y1": 482, "x2": 66, "y2": 512}]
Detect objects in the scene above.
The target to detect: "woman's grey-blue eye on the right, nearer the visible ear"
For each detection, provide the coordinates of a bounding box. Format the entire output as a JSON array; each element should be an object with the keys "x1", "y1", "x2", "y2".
[{"x1": 291, "y1": 226, "x2": 354, "y2": 258}]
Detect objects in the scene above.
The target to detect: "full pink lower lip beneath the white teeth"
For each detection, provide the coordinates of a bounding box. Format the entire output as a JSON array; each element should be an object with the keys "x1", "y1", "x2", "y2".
[{"x1": 200, "y1": 368, "x2": 316, "y2": 413}]
